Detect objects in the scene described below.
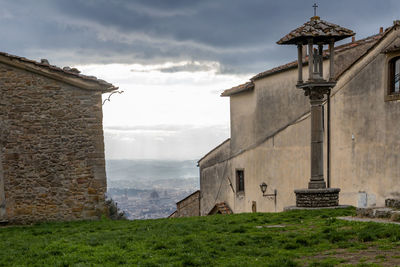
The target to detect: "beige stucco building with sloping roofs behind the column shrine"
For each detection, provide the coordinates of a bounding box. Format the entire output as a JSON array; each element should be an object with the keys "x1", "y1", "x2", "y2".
[{"x1": 198, "y1": 18, "x2": 400, "y2": 215}]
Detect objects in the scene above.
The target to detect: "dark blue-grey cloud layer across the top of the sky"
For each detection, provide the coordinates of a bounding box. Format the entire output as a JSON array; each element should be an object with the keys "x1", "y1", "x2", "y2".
[{"x1": 0, "y1": 0, "x2": 400, "y2": 73}]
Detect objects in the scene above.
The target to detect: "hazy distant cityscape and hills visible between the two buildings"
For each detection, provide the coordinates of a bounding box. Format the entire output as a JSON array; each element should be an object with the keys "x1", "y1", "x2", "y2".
[{"x1": 107, "y1": 160, "x2": 199, "y2": 220}]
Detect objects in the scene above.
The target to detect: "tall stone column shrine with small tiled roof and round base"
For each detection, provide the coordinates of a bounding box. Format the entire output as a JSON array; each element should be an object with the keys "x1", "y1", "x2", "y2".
[{"x1": 277, "y1": 15, "x2": 355, "y2": 207}]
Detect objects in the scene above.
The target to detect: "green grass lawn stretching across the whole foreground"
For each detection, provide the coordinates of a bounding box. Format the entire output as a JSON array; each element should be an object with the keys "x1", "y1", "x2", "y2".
[{"x1": 0, "y1": 208, "x2": 400, "y2": 267}]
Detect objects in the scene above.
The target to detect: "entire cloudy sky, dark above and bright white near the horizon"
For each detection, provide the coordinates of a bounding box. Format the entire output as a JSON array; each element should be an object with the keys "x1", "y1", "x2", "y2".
[{"x1": 0, "y1": 0, "x2": 400, "y2": 159}]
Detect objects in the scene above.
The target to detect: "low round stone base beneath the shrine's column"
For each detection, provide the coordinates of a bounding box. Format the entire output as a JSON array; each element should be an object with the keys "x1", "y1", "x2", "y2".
[{"x1": 294, "y1": 188, "x2": 340, "y2": 208}]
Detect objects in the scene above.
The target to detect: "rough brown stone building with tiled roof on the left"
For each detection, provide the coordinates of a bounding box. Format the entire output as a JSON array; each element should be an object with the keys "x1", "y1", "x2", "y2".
[{"x1": 0, "y1": 53, "x2": 116, "y2": 223}]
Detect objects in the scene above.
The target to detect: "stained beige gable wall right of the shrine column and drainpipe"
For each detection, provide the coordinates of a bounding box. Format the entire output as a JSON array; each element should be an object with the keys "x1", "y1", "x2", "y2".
[{"x1": 332, "y1": 31, "x2": 400, "y2": 209}]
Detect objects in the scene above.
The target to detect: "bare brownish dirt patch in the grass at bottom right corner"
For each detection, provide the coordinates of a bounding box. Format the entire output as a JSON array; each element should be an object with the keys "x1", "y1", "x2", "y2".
[{"x1": 299, "y1": 247, "x2": 400, "y2": 267}]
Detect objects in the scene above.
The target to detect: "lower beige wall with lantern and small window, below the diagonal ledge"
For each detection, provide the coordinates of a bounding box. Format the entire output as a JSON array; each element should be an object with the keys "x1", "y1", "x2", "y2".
[{"x1": 200, "y1": 116, "x2": 310, "y2": 215}]
